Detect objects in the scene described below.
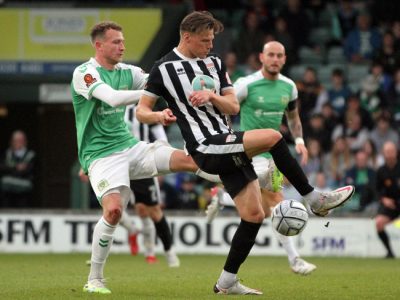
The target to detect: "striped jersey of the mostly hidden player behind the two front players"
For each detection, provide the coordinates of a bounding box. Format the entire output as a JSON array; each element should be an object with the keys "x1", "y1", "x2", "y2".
[{"x1": 125, "y1": 105, "x2": 168, "y2": 143}]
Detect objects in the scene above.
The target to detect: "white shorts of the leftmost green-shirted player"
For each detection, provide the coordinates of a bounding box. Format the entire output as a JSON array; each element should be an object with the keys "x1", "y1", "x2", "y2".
[{"x1": 89, "y1": 141, "x2": 177, "y2": 206}]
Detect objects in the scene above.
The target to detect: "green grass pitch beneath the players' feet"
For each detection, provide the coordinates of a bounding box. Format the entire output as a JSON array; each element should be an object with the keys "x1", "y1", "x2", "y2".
[{"x1": 0, "y1": 254, "x2": 400, "y2": 300}]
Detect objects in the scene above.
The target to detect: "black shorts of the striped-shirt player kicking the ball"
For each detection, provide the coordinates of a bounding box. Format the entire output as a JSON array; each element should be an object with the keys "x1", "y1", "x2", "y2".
[{"x1": 191, "y1": 131, "x2": 257, "y2": 198}]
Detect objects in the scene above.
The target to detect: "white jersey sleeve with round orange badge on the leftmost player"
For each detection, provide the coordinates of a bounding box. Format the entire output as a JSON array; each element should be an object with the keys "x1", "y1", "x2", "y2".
[{"x1": 72, "y1": 65, "x2": 104, "y2": 100}]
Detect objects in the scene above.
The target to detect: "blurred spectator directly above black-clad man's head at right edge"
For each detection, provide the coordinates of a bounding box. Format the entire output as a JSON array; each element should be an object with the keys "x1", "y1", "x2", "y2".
[{"x1": 370, "y1": 114, "x2": 399, "y2": 151}]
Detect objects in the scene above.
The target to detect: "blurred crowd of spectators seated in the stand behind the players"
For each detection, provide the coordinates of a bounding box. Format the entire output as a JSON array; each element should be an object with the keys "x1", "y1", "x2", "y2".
[{"x1": 3, "y1": 0, "x2": 400, "y2": 212}]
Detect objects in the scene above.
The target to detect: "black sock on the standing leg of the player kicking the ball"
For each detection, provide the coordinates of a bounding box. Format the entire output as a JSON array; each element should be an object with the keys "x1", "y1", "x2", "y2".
[{"x1": 224, "y1": 219, "x2": 261, "y2": 274}]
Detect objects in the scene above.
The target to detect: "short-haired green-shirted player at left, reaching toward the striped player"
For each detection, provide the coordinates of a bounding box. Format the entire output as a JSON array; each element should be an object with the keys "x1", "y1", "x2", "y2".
[{"x1": 71, "y1": 22, "x2": 217, "y2": 294}]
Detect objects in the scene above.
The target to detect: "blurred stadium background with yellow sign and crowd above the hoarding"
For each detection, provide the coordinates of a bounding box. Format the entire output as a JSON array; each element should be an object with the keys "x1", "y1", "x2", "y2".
[{"x1": 0, "y1": 0, "x2": 400, "y2": 255}]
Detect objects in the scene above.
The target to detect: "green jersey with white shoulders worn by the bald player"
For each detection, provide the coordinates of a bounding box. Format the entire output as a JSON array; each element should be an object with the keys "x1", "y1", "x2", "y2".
[{"x1": 234, "y1": 70, "x2": 298, "y2": 158}]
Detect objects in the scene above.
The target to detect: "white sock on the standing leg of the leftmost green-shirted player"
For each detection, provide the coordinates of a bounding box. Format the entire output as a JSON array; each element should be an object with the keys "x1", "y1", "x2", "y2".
[{"x1": 89, "y1": 217, "x2": 117, "y2": 280}]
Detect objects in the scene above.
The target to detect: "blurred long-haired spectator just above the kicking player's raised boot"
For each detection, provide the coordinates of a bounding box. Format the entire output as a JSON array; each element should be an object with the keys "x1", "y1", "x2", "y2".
[{"x1": 323, "y1": 136, "x2": 353, "y2": 187}]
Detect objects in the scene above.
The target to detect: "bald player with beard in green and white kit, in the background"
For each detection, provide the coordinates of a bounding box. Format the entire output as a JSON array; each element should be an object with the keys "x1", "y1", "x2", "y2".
[{"x1": 207, "y1": 41, "x2": 316, "y2": 275}]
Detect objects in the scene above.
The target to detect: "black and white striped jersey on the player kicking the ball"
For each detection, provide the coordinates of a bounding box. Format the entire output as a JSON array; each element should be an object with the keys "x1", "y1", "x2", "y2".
[{"x1": 144, "y1": 48, "x2": 233, "y2": 153}]
